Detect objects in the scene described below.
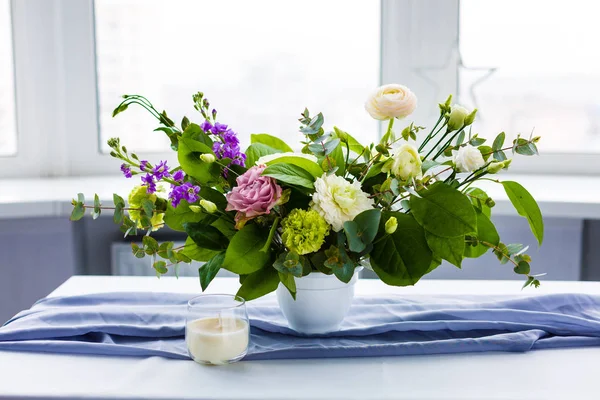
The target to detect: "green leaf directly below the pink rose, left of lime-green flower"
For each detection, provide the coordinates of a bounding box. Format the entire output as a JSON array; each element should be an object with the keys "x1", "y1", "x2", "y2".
[{"x1": 223, "y1": 224, "x2": 273, "y2": 275}]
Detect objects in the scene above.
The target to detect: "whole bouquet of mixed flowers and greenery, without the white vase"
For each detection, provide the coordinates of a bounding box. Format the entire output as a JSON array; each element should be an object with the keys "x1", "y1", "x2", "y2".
[{"x1": 71, "y1": 84, "x2": 544, "y2": 300}]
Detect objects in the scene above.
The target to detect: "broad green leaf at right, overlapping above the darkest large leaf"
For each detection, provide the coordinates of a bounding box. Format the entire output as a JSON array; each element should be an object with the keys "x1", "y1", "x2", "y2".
[{"x1": 410, "y1": 182, "x2": 477, "y2": 237}]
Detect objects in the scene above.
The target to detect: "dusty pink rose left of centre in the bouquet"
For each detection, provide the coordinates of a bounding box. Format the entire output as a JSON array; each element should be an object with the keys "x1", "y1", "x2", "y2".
[{"x1": 225, "y1": 165, "x2": 281, "y2": 220}]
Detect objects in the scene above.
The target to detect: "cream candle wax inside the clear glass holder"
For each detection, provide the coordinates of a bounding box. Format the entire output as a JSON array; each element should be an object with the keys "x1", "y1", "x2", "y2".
[{"x1": 185, "y1": 317, "x2": 249, "y2": 365}]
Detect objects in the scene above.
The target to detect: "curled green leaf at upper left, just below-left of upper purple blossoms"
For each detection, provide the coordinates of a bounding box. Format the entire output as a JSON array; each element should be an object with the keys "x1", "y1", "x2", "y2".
[{"x1": 177, "y1": 134, "x2": 220, "y2": 185}]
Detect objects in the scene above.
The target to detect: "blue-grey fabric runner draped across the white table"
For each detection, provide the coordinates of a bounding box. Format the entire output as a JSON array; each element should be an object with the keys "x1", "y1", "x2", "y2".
[{"x1": 0, "y1": 293, "x2": 600, "y2": 360}]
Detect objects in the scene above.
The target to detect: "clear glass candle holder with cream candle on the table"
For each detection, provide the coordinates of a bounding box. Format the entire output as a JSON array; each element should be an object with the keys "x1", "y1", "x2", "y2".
[{"x1": 185, "y1": 294, "x2": 250, "y2": 365}]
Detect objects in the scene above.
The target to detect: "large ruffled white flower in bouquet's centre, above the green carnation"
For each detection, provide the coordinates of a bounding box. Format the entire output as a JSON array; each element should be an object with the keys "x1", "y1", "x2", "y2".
[{"x1": 310, "y1": 174, "x2": 373, "y2": 232}]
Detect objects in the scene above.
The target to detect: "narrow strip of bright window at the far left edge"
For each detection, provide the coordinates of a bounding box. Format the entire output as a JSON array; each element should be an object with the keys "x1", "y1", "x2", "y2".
[{"x1": 0, "y1": 0, "x2": 17, "y2": 156}]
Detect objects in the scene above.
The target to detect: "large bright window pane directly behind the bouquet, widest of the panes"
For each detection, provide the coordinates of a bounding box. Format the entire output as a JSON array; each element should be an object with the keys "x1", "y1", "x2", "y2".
[{"x1": 95, "y1": 0, "x2": 380, "y2": 152}]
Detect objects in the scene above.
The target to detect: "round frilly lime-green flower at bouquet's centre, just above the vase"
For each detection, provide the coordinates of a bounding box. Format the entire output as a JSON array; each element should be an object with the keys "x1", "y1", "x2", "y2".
[{"x1": 281, "y1": 209, "x2": 329, "y2": 255}]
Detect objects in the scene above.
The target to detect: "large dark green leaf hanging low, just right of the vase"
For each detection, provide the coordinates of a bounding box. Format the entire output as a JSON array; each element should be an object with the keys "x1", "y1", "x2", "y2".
[{"x1": 370, "y1": 212, "x2": 433, "y2": 286}]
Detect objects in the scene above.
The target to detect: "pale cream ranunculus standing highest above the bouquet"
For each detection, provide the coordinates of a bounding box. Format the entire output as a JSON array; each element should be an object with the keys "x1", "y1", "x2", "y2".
[{"x1": 365, "y1": 83, "x2": 417, "y2": 121}]
